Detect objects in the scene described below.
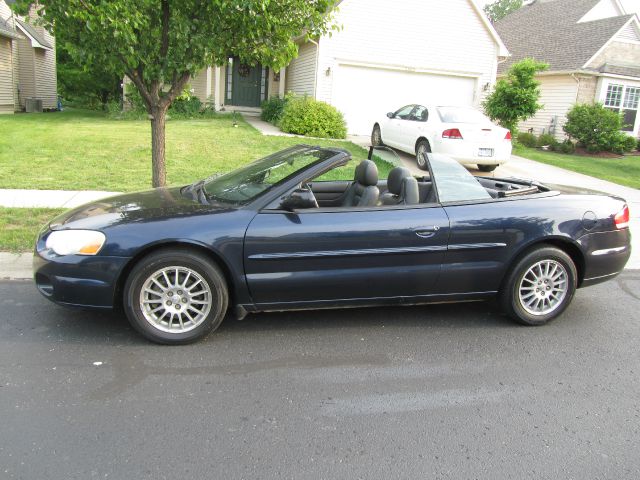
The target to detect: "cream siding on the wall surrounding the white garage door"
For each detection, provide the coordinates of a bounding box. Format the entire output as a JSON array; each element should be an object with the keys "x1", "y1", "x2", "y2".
[{"x1": 312, "y1": 0, "x2": 498, "y2": 106}]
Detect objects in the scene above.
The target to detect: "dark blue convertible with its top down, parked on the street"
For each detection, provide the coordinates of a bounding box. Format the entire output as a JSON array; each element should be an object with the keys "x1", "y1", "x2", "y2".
[{"x1": 34, "y1": 145, "x2": 631, "y2": 344}]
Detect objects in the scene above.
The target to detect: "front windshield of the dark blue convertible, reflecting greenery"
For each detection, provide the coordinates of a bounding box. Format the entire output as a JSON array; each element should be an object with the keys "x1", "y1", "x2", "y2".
[{"x1": 202, "y1": 146, "x2": 336, "y2": 205}]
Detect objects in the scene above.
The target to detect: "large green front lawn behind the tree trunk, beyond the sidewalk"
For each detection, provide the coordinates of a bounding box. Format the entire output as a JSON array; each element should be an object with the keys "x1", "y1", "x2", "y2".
[{"x1": 0, "y1": 110, "x2": 393, "y2": 191}]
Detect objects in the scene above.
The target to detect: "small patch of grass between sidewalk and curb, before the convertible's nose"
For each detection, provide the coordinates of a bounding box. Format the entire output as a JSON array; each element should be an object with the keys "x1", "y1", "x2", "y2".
[{"x1": 0, "y1": 208, "x2": 64, "y2": 252}]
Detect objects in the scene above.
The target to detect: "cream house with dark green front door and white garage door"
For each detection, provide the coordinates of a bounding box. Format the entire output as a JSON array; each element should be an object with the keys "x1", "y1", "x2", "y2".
[{"x1": 182, "y1": 0, "x2": 509, "y2": 134}]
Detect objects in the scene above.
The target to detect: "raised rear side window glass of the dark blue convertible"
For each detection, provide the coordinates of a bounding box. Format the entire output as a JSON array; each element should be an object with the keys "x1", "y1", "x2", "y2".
[{"x1": 428, "y1": 153, "x2": 491, "y2": 203}]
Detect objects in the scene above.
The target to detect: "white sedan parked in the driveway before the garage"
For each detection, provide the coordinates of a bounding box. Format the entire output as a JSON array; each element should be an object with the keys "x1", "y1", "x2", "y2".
[{"x1": 371, "y1": 104, "x2": 511, "y2": 172}]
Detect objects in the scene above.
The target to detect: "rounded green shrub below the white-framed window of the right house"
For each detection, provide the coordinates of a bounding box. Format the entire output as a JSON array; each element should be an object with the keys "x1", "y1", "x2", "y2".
[{"x1": 563, "y1": 103, "x2": 628, "y2": 153}]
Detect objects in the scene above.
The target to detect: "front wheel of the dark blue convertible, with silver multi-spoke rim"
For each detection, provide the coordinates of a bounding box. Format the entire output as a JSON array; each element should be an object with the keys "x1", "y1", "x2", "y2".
[{"x1": 123, "y1": 250, "x2": 229, "y2": 345}]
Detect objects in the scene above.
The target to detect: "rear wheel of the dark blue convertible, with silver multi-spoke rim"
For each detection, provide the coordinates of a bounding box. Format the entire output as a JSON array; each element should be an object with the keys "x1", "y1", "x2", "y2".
[{"x1": 499, "y1": 247, "x2": 578, "y2": 325}]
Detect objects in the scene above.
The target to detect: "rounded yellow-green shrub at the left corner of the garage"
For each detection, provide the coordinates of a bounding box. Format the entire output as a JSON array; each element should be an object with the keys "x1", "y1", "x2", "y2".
[{"x1": 280, "y1": 97, "x2": 347, "y2": 138}]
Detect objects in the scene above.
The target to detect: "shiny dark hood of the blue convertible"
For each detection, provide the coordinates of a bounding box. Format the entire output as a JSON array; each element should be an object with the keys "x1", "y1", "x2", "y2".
[{"x1": 49, "y1": 187, "x2": 231, "y2": 230}]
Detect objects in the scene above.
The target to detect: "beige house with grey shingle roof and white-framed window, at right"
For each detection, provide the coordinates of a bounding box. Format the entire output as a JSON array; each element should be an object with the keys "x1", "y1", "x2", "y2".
[{"x1": 495, "y1": 0, "x2": 640, "y2": 140}]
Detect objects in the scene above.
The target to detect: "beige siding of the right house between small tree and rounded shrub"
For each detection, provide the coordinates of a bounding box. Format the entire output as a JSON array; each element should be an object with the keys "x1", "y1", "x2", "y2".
[{"x1": 518, "y1": 75, "x2": 578, "y2": 140}]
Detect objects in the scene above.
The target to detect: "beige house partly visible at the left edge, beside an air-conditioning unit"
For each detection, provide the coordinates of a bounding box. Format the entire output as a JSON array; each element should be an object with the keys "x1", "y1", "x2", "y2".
[{"x1": 0, "y1": 0, "x2": 57, "y2": 113}]
